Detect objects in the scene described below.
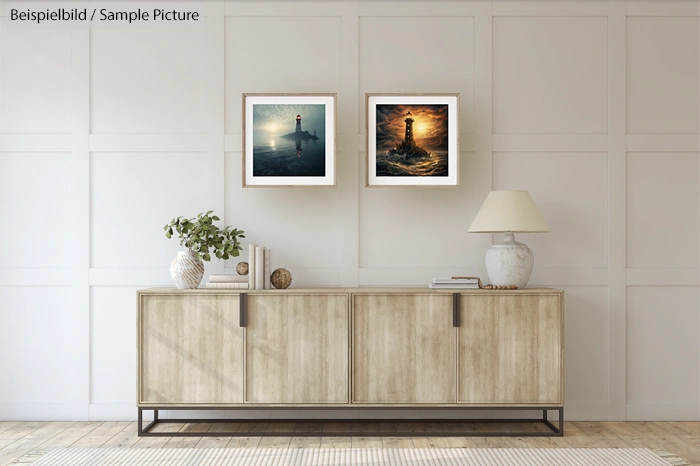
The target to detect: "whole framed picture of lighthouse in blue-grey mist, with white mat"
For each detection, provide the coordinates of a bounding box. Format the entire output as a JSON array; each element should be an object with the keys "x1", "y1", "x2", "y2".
[{"x1": 243, "y1": 94, "x2": 336, "y2": 188}]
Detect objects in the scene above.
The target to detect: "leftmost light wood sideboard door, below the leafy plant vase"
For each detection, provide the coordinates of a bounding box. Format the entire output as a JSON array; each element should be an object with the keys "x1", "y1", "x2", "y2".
[{"x1": 138, "y1": 293, "x2": 243, "y2": 405}]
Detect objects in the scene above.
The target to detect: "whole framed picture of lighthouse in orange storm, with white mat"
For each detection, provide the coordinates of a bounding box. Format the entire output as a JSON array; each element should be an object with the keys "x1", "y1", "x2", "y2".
[{"x1": 365, "y1": 94, "x2": 459, "y2": 187}]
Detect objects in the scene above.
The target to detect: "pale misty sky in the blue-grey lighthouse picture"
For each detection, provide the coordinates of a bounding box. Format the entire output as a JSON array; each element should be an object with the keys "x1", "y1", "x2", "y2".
[{"x1": 253, "y1": 104, "x2": 326, "y2": 146}]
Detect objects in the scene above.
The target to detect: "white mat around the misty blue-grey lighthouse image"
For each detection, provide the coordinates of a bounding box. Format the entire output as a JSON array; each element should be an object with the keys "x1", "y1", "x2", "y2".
[{"x1": 243, "y1": 95, "x2": 335, "y2": 186}]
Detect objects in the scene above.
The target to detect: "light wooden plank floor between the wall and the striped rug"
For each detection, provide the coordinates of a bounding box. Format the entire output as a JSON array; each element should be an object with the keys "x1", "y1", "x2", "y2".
[{"x1": 0, "y1": 422, "x2": 700, "y2": 466}]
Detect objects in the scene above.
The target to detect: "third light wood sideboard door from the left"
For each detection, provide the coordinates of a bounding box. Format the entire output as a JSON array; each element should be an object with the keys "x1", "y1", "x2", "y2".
[{"x1": 352, "y1": 294, "x2": 457, "y2": 404}]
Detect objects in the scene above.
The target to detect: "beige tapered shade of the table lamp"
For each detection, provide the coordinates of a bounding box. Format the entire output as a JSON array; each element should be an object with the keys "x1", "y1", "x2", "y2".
[{"x1": 469, "y1": 191, "x2": 550, "y2": 233}]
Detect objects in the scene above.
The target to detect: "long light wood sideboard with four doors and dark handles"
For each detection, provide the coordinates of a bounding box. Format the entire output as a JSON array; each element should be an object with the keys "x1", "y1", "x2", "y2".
[{"x1": 137, "y1": 288, "x2": 564, "y2": 436}]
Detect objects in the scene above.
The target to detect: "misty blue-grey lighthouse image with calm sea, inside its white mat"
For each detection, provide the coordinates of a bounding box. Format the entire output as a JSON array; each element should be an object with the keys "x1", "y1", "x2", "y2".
[{"x1": 253, "y1": 104, "x2": 326, "y2": 177}]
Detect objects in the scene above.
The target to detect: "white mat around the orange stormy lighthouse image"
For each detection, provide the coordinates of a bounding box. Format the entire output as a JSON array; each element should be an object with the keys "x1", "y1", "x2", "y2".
[{"x1": 367, "y1": 95, "x2": 459, "y2": 186}]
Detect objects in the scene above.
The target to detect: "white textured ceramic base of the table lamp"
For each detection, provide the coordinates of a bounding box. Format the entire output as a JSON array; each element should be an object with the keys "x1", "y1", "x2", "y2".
[{"x1": 486, "y1": 231, "x2": 535, "y2": 289}]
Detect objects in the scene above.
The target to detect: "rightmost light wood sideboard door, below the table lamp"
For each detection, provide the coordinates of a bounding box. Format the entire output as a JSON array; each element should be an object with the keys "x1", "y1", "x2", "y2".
[{"x1": 459, "y1": 293, "x2": 564, "y2": 405}]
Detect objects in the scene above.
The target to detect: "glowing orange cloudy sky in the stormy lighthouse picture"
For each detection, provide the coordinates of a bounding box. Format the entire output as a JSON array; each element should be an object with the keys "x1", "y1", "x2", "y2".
[{"x1": 377, "y1": 104, "x2": 448, "y2": 152}]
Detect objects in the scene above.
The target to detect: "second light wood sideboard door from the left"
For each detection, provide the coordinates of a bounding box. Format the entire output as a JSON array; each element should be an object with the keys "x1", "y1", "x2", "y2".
[{"x1": 245, "y1": 292, "x2": 350, "y2": 404}]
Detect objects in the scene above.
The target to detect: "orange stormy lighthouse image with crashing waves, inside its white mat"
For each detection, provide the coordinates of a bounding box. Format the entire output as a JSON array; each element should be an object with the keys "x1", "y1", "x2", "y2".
[{"x1": 376, "y1": 104, "x2": 448, "y2": 177}]
